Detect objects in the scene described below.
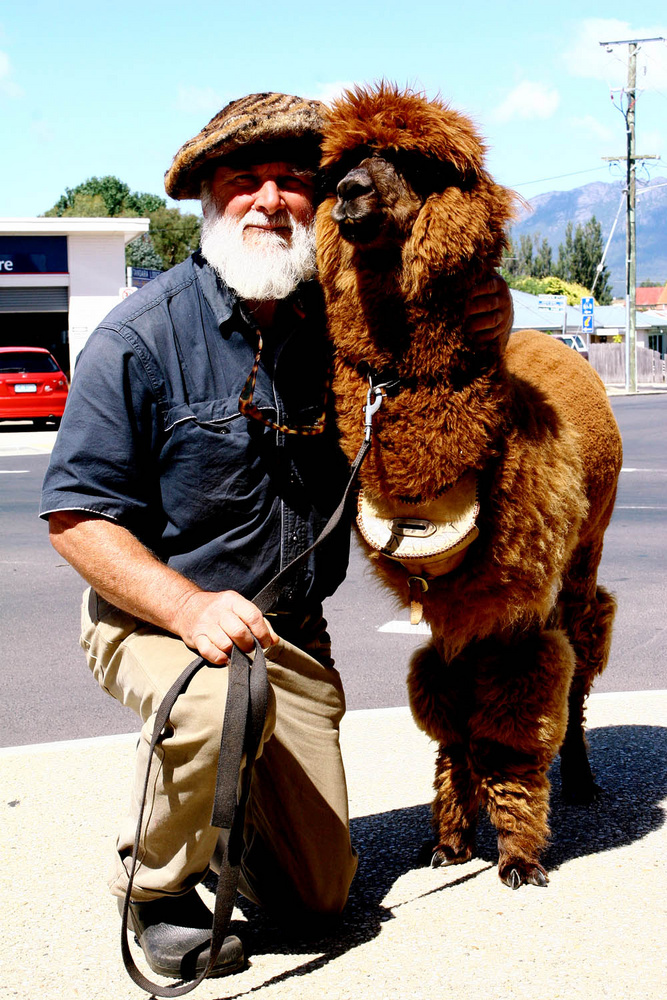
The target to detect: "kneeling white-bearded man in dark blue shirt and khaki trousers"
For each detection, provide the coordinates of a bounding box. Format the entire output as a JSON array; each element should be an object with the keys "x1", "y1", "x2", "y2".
[{"x1": 42, "y1": 94, "x2": 511, "y2": 977}]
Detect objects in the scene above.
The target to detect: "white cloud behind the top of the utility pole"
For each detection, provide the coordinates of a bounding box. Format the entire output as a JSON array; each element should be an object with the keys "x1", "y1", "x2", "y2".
[{"x1": 563, "y1": 18, "x2": 667, "y2": 90}]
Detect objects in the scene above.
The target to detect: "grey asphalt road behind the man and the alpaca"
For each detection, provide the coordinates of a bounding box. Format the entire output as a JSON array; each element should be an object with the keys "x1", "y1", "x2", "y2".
[{"x1": 0, "y1": 394, "x2": 667, "y2": 746}]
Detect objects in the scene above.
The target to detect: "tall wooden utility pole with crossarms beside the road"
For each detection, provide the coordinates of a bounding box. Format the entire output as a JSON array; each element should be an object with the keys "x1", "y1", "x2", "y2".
[{"x1": 600, "y1": 38, "x2": 665, "y2": 393}]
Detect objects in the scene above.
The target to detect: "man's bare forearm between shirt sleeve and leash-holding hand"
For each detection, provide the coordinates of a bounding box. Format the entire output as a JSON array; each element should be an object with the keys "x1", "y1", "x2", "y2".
[{"x1": 49, "y1": 511, "x2": 202, "y2": 634}]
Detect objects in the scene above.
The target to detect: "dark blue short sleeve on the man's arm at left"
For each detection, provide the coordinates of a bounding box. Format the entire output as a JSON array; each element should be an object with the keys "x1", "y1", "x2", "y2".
[{"x1": 40, "y1": 327, "x2": 162, "y2": 545}]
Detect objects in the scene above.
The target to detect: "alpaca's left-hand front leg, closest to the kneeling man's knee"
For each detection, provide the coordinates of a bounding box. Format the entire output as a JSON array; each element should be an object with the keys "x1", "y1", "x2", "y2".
[{"x1": 408, "y1": 644, "x2": 480, "y2": 868}]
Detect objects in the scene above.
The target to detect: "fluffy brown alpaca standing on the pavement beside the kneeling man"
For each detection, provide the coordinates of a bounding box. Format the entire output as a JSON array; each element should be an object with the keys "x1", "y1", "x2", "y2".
[{"x1": 317, "y1": 84, "x2": 621, "y2": 888}]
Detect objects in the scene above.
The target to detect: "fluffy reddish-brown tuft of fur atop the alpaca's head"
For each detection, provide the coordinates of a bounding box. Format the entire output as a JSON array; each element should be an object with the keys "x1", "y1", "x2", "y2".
[{"x1": 321, "y1": 82, "x2": 486, "y2": 179}]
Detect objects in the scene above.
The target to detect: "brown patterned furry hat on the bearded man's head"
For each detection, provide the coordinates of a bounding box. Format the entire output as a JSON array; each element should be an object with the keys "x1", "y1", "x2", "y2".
[{"x1": 164, "y1": 93, "x2": 324, "y2": 200}]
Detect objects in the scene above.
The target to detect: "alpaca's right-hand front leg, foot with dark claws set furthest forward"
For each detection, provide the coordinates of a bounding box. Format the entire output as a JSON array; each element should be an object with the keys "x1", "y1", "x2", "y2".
[{"x1": 470, "y1": 630, "x2": 574, "y2": 889}]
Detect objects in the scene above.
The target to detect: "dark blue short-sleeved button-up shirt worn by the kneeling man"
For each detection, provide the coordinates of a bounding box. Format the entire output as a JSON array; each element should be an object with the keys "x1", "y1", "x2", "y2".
[{"x1": 41, "y1": 253, "x2": 349, "y2": 610}]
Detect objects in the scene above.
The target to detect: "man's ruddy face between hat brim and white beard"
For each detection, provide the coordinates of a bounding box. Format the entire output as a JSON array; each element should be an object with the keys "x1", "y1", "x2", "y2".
[{"x1": 211, "y1": 162, "x2": 314, "y2": 245}]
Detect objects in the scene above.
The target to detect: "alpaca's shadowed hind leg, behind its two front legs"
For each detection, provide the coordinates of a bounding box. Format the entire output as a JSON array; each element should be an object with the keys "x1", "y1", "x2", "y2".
[{"x1": 560, "y1": 587, "x2": 616, "y2": 804}]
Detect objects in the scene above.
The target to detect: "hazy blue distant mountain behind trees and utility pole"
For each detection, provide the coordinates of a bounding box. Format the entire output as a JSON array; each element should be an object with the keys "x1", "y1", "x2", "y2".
[{"x1": 512, "y1": 178, "x2": 667, "y2": 296}]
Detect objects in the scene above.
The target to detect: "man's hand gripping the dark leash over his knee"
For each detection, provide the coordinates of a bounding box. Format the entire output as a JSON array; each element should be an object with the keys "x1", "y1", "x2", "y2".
[{"x1": 172, "y1": 590, "x2": 278, "y2": 664}]
